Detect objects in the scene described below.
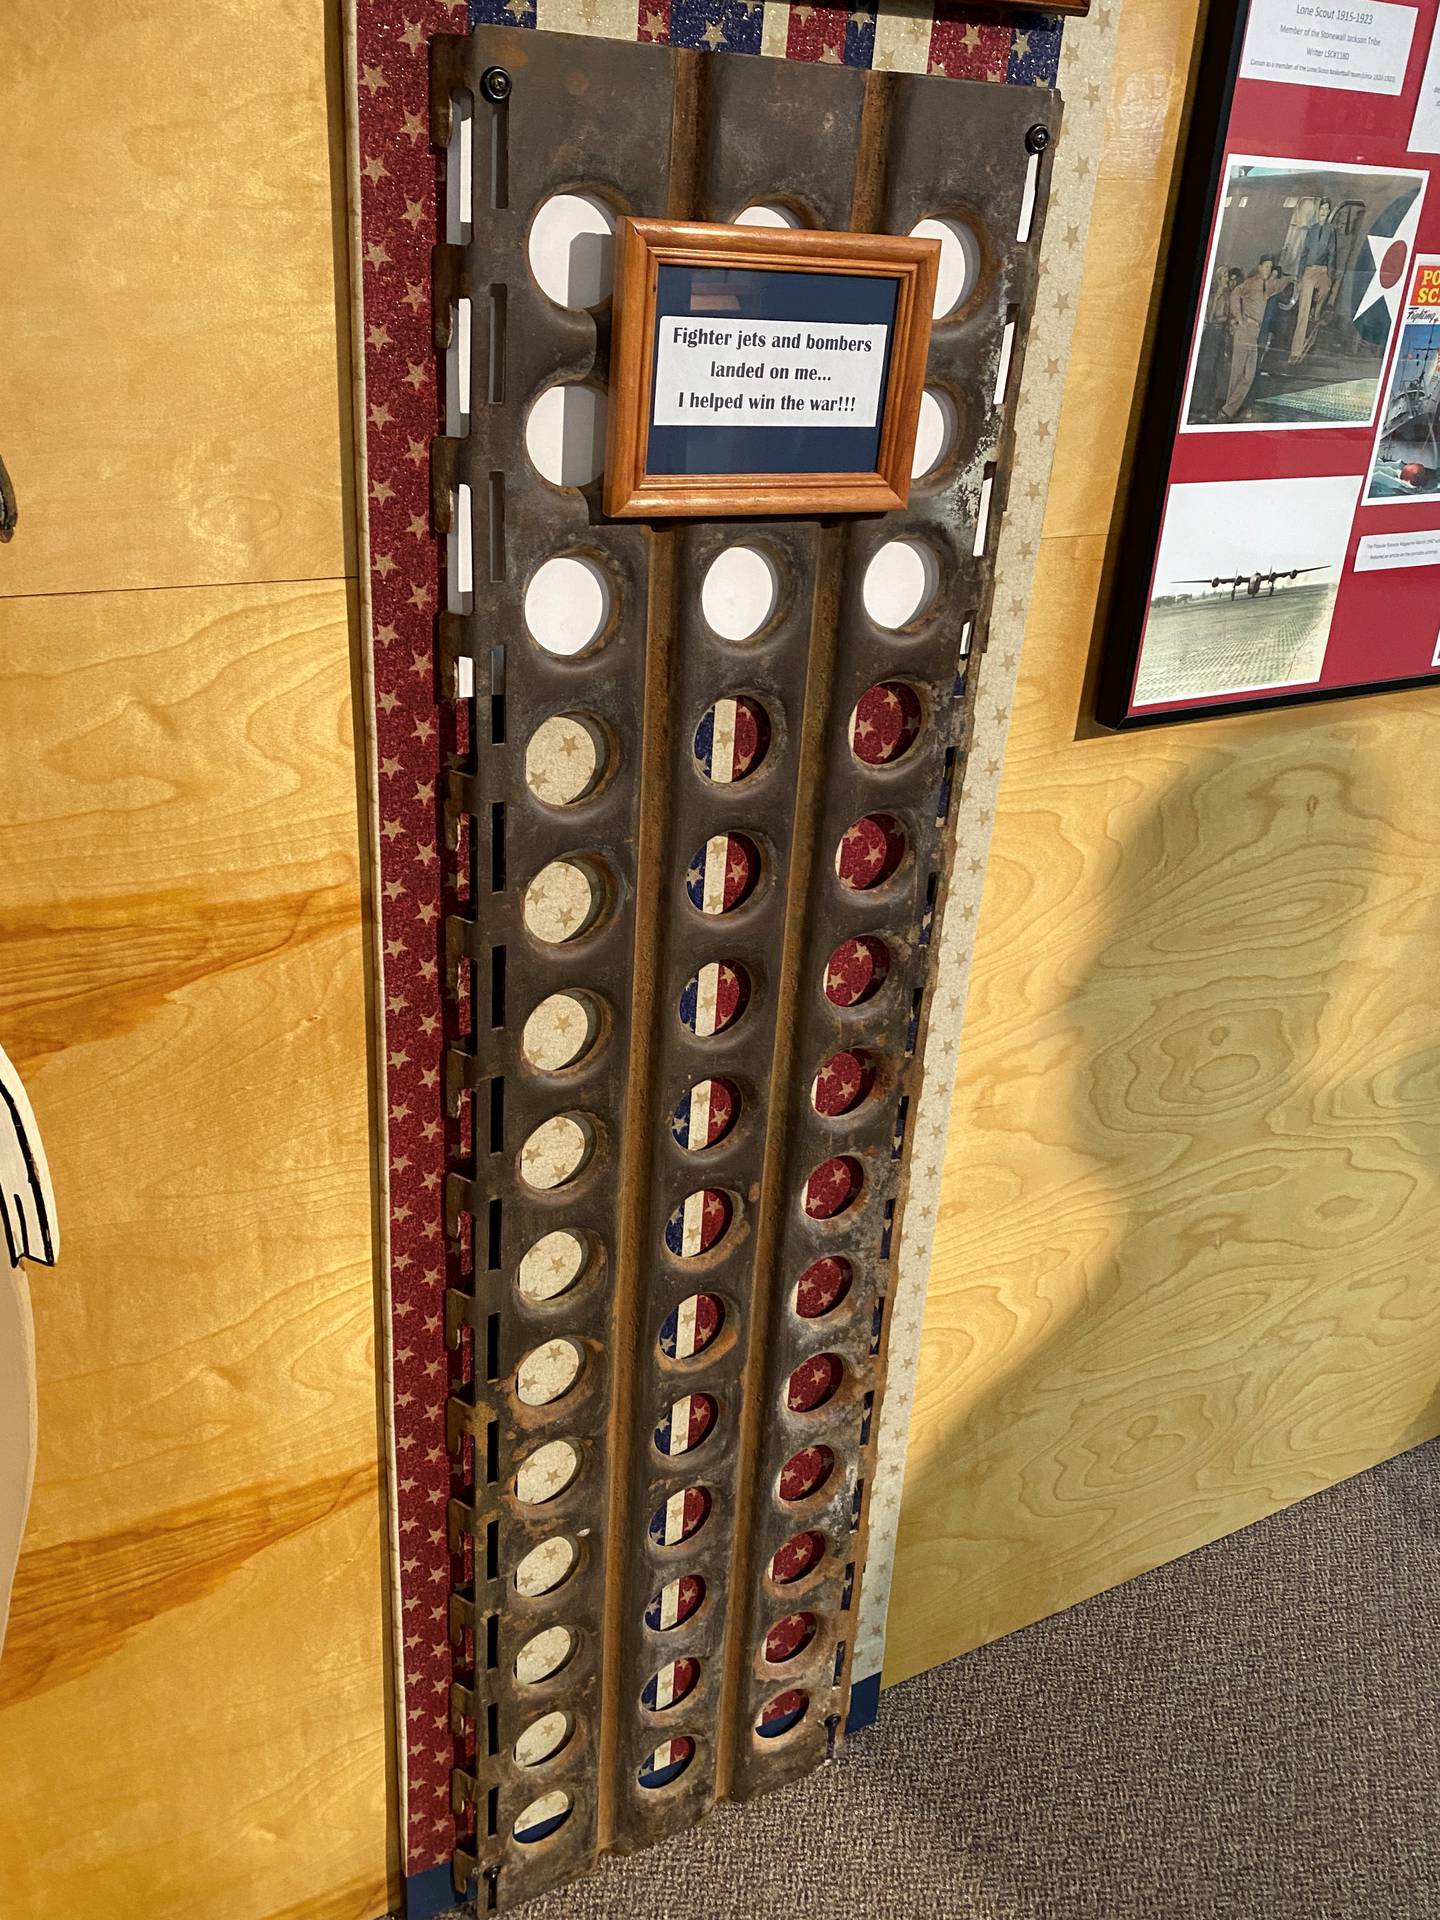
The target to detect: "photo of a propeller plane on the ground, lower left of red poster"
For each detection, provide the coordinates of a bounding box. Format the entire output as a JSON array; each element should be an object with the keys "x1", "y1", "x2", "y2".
[{"x1": 1135, "y1": 474, "x2": 1359, "y2": 707}]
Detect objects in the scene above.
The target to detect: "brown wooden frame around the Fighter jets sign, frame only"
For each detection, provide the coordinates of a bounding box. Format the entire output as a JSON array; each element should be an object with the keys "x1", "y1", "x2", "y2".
[{"x1": 605, "y1": 217, "x2": 941, "y2": 518}]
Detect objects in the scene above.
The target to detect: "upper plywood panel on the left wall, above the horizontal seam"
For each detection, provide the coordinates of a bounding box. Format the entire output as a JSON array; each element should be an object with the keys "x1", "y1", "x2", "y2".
[{"x1": 0, "y1": 0, "x2": 353, "y2": 593}]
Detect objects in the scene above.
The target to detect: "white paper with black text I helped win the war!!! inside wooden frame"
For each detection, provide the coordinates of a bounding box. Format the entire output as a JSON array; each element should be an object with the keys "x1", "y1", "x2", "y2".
[{"x1": 651, "y1": 313, "x2": 889, "y2": 426}]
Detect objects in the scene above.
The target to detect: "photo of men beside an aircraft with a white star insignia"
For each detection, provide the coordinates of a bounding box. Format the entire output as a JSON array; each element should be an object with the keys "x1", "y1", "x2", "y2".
[{"x1": 1183, "y1": 157, "x2": 1425, "y2": 430}]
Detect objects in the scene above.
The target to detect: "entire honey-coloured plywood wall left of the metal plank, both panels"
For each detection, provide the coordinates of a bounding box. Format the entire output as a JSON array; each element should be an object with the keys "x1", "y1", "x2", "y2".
[{"x1": 0, "y1": 0, "x2": 390, "y2": 1920}]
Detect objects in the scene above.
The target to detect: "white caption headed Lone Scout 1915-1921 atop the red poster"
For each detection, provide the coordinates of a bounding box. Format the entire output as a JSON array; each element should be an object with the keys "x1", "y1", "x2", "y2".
[{"x1": 1240, "y1": 0, "x2": 1415, "y2": 94}]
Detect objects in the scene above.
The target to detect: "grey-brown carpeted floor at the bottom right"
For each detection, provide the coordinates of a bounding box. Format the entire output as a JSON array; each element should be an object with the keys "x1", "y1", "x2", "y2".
[{"x1": 433, "y1": 1442, "x2": 1440, "y2": 1920}]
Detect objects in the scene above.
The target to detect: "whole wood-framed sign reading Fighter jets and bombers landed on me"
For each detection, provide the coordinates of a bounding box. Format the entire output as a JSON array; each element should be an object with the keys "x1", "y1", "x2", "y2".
[{"x1": 605, "y1": 219, "x2": 939, "y2": 518}]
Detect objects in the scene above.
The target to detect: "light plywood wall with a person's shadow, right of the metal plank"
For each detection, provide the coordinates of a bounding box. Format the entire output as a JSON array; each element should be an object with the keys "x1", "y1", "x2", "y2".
[{"x1": 885, "y1": 0, "x2": 1440, "y2": 1680}]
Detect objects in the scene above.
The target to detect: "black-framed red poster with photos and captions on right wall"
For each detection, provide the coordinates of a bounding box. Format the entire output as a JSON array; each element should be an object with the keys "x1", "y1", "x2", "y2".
[{"x1": 1096, "y1": 0, "x2": 1440, "y2": 728}]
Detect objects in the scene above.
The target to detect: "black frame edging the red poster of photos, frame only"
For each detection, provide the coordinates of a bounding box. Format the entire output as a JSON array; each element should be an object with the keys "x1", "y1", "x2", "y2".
[{"x1": 1092, "y1": 0, "x2": 1440, "y2": 733}]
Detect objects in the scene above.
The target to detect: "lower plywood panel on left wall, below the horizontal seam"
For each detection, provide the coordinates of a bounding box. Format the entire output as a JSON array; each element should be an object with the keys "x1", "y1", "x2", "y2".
[{"x1": 0, "y1": 582, "x2": 390, "y2": 1920}]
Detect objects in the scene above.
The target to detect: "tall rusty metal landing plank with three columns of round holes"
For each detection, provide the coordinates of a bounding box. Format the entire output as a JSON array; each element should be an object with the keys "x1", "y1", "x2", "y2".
[{"x1": 432, "y1": 29, "x2": 1058, "y2": 1910}]
